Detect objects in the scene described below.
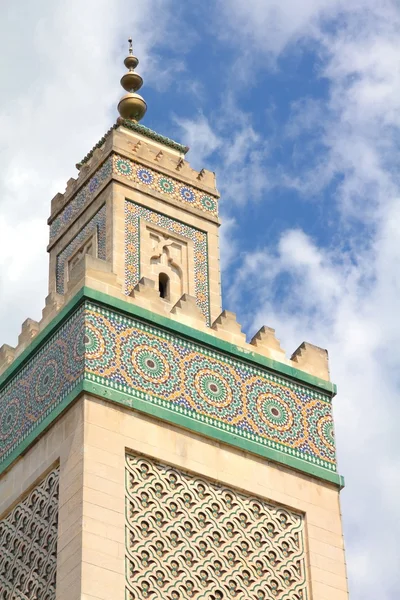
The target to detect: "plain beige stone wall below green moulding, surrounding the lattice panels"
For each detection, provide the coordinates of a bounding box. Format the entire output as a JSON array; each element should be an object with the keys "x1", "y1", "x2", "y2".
[{"x1": 0, "y1": 395, "x2": 348, "y2": 600}]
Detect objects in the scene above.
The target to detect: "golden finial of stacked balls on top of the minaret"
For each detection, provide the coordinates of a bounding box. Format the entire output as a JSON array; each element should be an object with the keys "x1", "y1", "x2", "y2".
[{"x1": 118, "y1": 38, "x2": 147, "y2": 121}]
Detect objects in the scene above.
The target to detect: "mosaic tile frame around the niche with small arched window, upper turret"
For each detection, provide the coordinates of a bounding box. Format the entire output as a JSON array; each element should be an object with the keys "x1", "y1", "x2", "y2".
[{"x1": 125, "y1": 200, "x2": 210, "y2": 325}]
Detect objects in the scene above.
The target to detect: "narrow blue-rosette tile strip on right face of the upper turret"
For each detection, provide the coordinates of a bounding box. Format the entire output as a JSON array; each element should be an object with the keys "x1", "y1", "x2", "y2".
[{"x1": 113, "y1": 154, "x2": 218, "y2": 217}]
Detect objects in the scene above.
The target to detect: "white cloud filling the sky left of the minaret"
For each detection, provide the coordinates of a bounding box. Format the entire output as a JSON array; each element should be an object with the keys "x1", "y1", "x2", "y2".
[{"x1": 0, "y1": 0, "x2": 175, "y2": 345}]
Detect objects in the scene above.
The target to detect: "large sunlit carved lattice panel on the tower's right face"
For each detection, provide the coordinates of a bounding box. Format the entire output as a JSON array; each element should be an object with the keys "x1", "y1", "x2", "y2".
[{"x1": 125, "y1": 454, "x2": 308, "y2": 600}]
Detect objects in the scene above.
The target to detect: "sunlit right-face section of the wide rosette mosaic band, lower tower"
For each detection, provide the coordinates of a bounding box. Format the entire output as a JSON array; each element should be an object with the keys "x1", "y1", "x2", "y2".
[{"x1": 86, "y1": 303, "x2": 336, "y2": 471}]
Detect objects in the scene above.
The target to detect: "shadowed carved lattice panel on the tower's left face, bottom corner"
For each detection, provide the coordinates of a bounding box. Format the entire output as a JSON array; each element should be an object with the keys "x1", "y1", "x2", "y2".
[{"x1": 0, "y1": 467, "x2": 59, "y2": 600}]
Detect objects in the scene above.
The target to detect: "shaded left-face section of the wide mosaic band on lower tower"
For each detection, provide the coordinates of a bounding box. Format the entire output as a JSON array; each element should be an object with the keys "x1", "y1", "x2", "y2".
[{"x1": 0, "y1": 307, "x2": 85, "y2": 463}]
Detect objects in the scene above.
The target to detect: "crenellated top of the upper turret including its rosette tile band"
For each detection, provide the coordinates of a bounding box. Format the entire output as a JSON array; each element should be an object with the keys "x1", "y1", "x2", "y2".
[{"x1": 48, "y1": 126, "x2": 219, "y2": 249}]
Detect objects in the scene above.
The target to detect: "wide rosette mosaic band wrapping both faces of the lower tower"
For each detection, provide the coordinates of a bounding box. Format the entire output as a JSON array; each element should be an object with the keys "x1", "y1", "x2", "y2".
[{"x1": 0, "y1": 300, "x2": 336, "y2": 473}]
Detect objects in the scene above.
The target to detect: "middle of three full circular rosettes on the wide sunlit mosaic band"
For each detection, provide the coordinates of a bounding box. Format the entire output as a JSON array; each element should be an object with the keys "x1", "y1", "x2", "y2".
[{"x1": 184, "y1": 352, "x2": 243, "y2": 425}]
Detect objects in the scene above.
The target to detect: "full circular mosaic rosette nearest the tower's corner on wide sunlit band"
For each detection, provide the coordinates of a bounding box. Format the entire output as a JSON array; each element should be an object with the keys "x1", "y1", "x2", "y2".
[{"x1": 121, "y1": 330, "x2": 181, "y2": 400}]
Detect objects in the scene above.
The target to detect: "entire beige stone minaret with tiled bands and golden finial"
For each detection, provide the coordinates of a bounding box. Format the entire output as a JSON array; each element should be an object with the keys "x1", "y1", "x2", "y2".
[{"x1": 0, "y1": 40, "x2": 348, "y2": 600}]
